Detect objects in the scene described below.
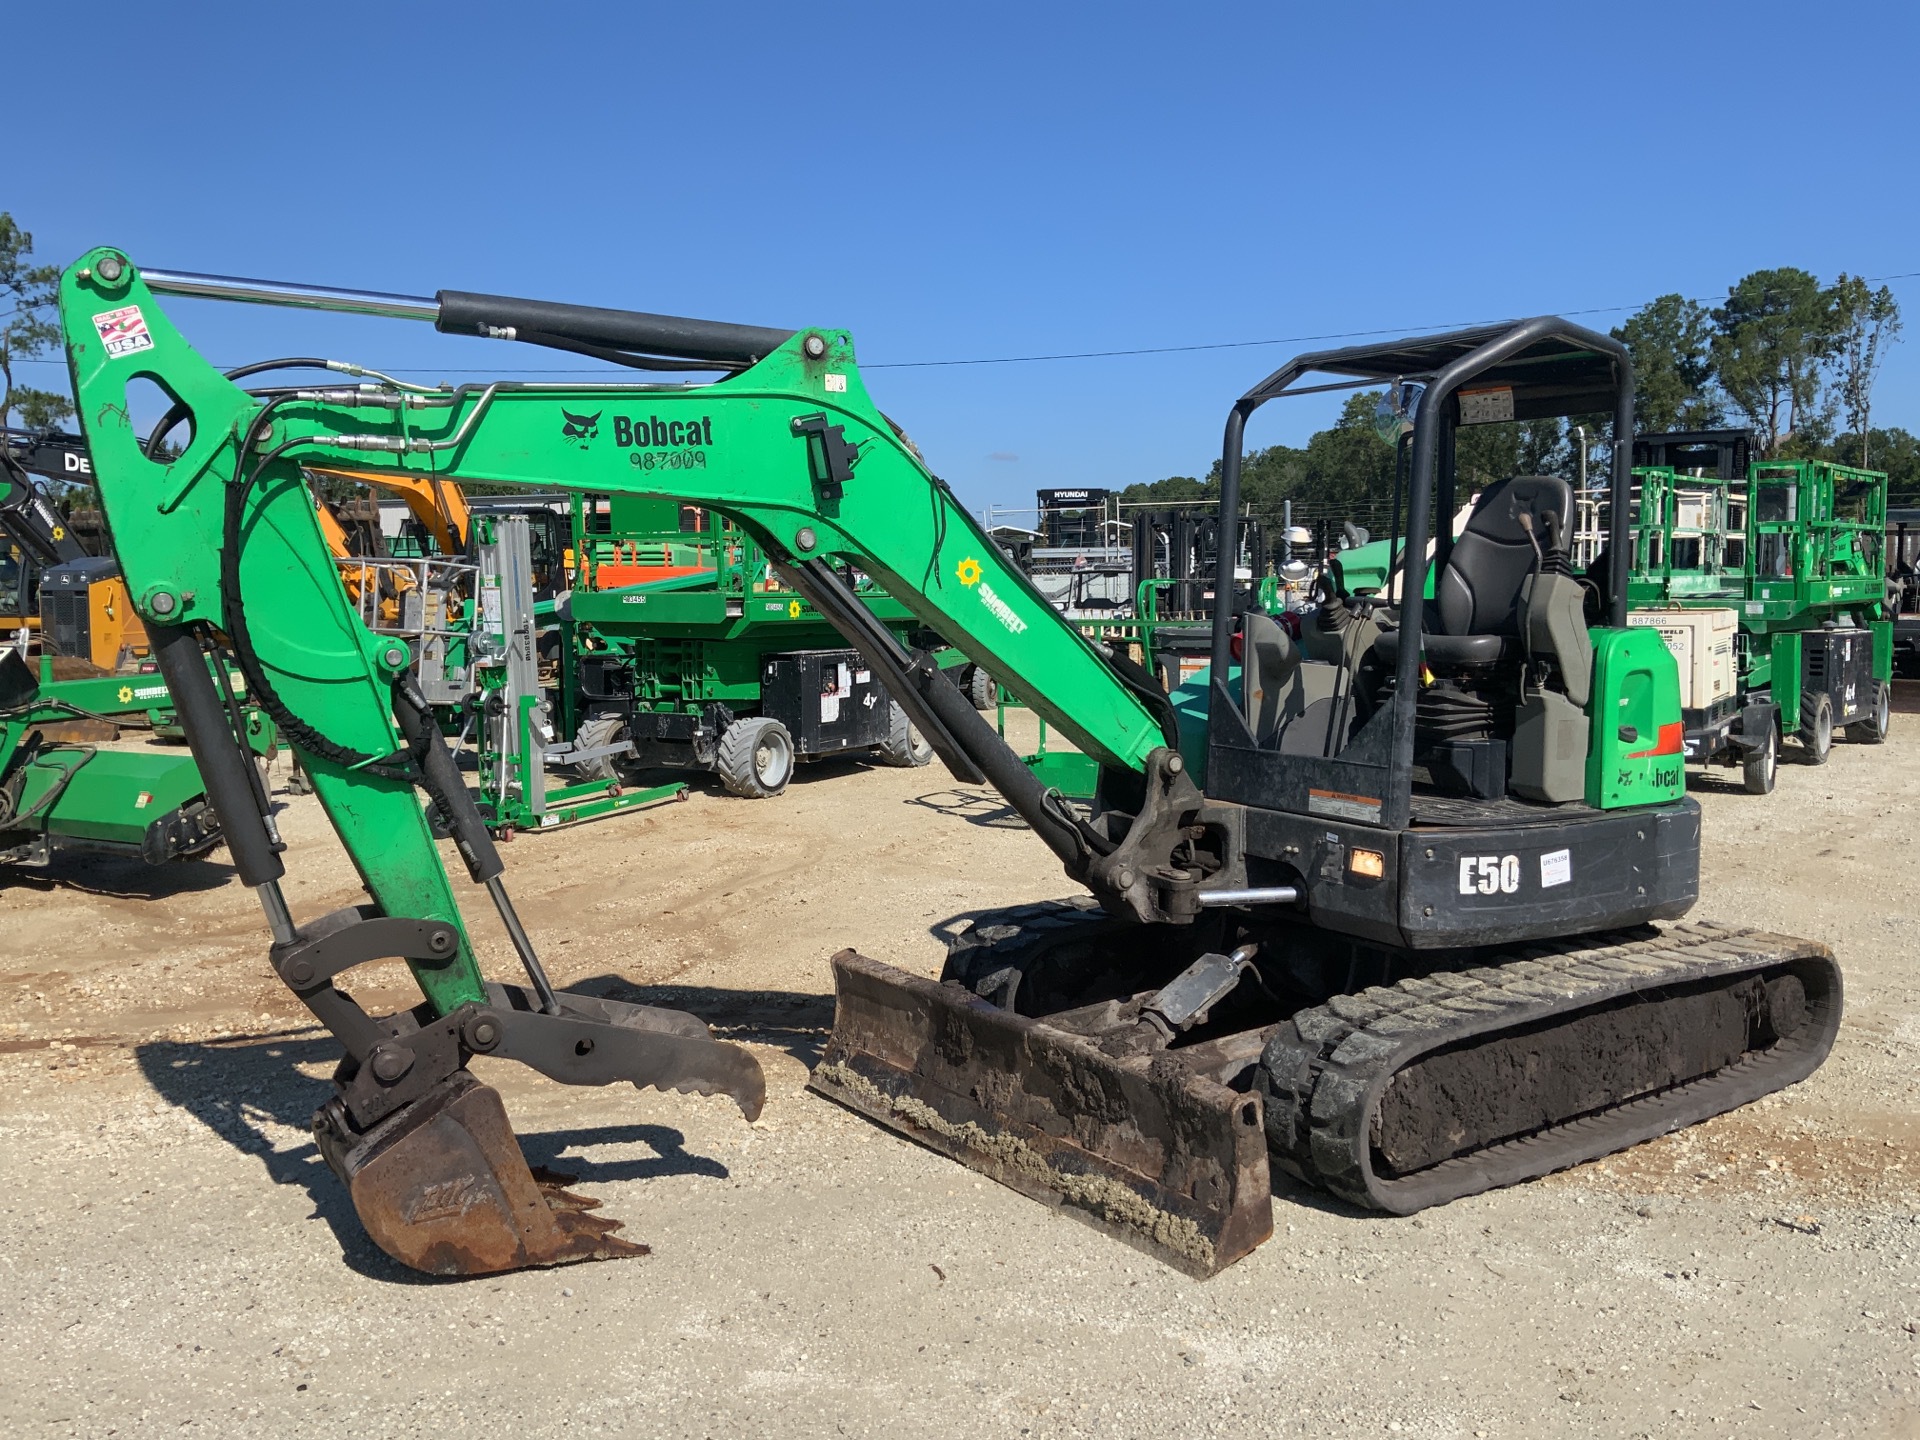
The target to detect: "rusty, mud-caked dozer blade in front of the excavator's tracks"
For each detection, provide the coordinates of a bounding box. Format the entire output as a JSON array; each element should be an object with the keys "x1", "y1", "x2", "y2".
[{"x1": 810, "y1": 950, "x2": 1273, "y2": 1277}]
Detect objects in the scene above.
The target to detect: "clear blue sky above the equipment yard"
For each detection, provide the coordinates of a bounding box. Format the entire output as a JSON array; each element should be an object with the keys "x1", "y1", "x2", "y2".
[{"x1": 0, "y1": 0, "x2": 1920, "y2": 507}]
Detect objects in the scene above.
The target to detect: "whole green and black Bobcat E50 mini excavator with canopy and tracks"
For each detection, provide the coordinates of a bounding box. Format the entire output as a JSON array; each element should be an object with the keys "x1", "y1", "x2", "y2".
[{"x1": 61, "y1": 250, "x2": 1839, "y2": 1275}]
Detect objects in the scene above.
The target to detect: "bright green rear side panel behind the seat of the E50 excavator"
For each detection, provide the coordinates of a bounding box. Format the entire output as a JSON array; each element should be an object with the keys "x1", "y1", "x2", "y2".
[{"x1": 1586, "y1": 630, "x2": 1686, "y2": 810}]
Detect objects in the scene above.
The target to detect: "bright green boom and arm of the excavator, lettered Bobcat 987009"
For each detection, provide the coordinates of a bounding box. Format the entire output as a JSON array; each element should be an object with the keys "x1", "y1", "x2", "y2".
[{"x1": 61, "y1": 259, "x2": 1167, "y2": 1014}]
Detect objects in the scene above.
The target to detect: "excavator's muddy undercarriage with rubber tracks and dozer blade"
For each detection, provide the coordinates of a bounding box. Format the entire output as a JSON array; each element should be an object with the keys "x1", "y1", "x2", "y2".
[{"x1": 812, "y1": 900, "x2": 1841, "y2": 1275}]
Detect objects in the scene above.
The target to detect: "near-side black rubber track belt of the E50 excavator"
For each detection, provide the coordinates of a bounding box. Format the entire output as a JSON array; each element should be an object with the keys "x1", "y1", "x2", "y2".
[{"x1": 1258, "y1": 922, "x2": 1841, "y2": 1215}]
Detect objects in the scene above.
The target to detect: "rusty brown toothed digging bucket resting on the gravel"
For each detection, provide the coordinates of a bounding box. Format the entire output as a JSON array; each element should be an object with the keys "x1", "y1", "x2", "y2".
[{"x1": 315, "y1": 1069, "x2": 647, "y2": 1275}]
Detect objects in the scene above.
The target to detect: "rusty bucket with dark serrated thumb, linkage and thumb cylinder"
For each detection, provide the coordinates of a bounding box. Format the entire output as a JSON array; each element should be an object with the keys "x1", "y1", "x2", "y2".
[{"x1": 295, "y1": 695, "x2": 766, "y2": 1275}]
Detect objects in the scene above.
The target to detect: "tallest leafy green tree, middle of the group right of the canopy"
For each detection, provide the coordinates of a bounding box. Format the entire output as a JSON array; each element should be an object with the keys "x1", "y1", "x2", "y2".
[{"x1": 1713, "y1": 267, "x2": 1837, "y2": 457}]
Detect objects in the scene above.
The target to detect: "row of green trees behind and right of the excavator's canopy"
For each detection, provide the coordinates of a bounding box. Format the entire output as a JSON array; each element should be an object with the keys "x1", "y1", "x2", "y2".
[{"x1": 1121, "y1": 267, "x2": 1920, "y2": 538}]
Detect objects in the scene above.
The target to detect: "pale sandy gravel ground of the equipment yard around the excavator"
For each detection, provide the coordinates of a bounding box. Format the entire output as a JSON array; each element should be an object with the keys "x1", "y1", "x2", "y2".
[{"x1": 0, "y1": 685, "x2": 1920, "y2": 1438}]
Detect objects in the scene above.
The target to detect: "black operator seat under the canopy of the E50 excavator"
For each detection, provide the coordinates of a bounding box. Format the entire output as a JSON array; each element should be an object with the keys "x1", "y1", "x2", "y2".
[{"x1": 1375, "y1": 474, "x2": 1572, "y2": 668}]
